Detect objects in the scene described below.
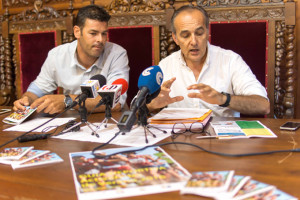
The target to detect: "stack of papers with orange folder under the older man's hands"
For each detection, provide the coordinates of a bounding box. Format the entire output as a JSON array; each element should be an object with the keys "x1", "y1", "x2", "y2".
[{"x1": 149, "y1": 108, "x2": 212, "y2": 129}]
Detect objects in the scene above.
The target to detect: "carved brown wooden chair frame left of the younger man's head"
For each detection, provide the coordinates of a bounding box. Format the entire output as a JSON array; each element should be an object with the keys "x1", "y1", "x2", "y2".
[{"x1": 0, "y1": 0, "x2": 74, "y2": 105}]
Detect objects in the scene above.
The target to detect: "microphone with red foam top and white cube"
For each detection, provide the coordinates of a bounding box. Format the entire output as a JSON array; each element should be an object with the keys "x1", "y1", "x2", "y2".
[{"x1": 96, "y1": 78, "x2": 128, "y2": 108}]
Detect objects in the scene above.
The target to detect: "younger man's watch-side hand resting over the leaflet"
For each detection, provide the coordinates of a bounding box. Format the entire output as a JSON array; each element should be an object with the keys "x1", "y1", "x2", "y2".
[{"x1": 30, "y1": 94, "x2": 65, "y2": 114}]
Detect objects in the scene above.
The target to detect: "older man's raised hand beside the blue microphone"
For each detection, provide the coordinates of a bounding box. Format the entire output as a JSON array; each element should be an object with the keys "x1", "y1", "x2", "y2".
[{"x1": 147, "y1": 77, "x2": 183, "y2": 111}]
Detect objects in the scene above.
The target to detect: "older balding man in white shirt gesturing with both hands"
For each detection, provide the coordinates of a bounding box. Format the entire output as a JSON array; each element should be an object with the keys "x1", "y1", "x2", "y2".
[{"x1": 148, "y1": 5, "x2": 270, "y2": 117}]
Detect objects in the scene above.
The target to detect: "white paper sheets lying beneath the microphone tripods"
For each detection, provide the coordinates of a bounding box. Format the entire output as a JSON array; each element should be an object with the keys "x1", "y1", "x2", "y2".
[{"x1": 52, "y1": 123, "x2": 171, "y2": 147}]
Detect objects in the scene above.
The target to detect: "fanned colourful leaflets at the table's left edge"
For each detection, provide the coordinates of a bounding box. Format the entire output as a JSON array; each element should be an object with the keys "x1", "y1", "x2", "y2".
[{"x1": 0, "y1": 146, "x2": 63, "y2": 169}]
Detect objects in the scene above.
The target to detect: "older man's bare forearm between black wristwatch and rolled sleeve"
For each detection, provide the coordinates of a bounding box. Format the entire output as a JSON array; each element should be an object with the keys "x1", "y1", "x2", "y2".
[{"x1": 229, "y1": 95, "x2": 270, "y2": 115}]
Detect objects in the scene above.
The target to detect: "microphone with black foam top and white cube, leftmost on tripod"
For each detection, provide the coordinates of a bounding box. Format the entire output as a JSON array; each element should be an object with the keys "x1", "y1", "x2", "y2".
[{"x1": 73, "y1": 74, "x2": 106, "y2": 104}]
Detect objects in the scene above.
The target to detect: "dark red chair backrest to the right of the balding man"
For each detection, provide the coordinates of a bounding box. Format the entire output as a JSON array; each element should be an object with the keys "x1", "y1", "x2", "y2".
[{"x1": 210, "y1": 21, "x2": 268, "y2": 117}]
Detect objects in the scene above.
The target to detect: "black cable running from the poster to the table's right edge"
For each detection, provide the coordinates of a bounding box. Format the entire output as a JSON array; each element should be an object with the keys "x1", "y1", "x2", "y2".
[{"x1": 92, "y1": 142, "x2": 300, "y2": 159}]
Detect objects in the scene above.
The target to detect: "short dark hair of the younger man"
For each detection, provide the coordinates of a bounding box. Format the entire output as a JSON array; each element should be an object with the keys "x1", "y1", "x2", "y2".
[{"x1": 75, "y1": 5, "x2": 110, "y2": 29}]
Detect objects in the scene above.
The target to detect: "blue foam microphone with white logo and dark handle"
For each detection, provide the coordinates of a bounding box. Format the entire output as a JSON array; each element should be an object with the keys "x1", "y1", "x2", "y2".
[{"x1": 117, "y1": 65, "x2": 163, "y2": 132}]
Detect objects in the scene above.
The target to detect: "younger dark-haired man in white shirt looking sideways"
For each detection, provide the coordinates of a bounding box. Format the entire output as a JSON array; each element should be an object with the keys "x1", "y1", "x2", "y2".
[{"x1": 14, "y1": 5, "x2": 129, "y2": 114}]
